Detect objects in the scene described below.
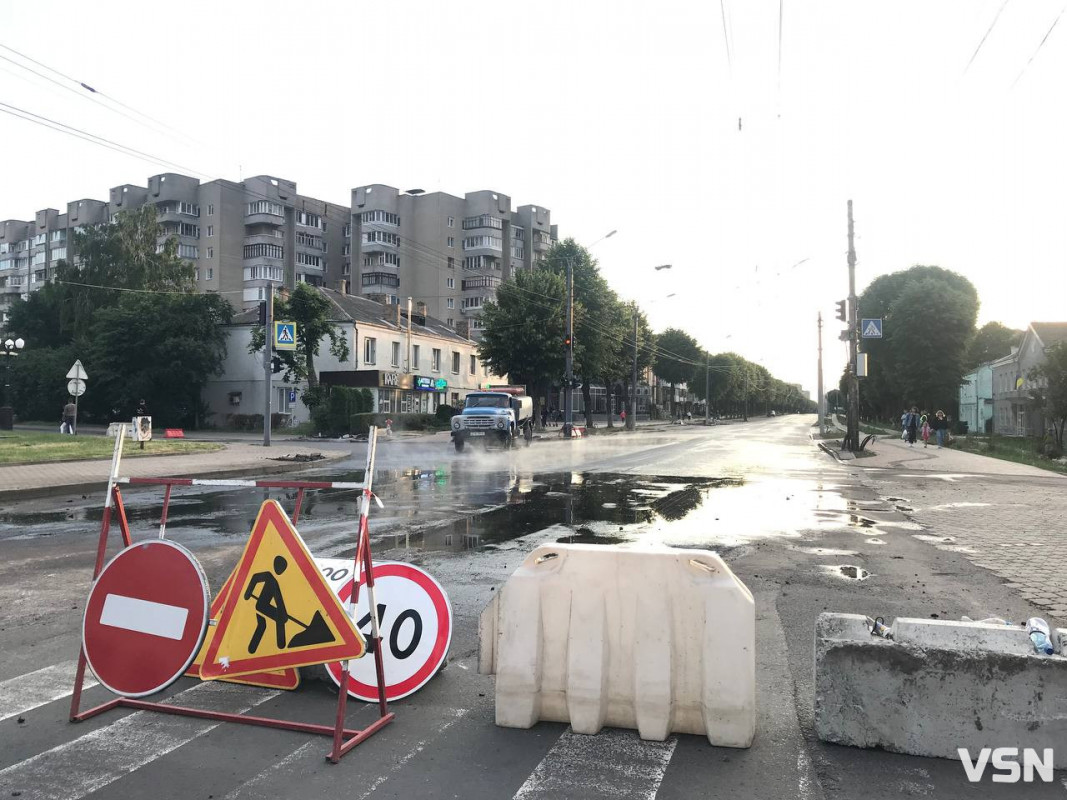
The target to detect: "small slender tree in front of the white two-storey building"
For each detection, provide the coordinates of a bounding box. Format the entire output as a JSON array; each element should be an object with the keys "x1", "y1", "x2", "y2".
[{"x1": 249, "y1": 284, "x2": 349, "y2": 395}]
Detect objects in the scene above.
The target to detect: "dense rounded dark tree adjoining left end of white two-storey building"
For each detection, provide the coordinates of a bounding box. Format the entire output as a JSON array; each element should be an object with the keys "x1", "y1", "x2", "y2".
[{"x1": 83, "y1": 294, "x2": 233, "y2": 427}]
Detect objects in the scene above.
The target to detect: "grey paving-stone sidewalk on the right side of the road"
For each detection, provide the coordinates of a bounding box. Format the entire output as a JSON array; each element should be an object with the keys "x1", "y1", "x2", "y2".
[{"x1": 849, "y1": 438, "x2": 1067, "y2": 627}]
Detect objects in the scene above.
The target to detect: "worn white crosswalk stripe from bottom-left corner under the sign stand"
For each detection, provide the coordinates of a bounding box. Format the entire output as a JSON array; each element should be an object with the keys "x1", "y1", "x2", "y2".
[{"x1": 0, "y1": 682, "x2": 281, "y2": 800}]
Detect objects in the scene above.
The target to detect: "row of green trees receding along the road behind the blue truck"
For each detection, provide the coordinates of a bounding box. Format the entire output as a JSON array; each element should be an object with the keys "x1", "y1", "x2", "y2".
[{"x1": 479, "y1": 239, "x2": 814, "y2": 425}]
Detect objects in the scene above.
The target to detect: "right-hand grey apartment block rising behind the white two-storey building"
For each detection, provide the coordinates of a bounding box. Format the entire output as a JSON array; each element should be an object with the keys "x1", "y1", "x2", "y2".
[{"x1": 344, "y1": 183, "x2": 557, "y2": 339}]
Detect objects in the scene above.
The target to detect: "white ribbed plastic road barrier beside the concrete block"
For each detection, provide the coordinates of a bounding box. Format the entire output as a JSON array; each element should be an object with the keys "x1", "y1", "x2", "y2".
[{"x1": 479, "y1": 544, "x2": 755, "y2": 748}]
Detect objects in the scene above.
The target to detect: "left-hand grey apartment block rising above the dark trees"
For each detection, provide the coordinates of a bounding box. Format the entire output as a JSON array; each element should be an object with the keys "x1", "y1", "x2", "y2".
[{"x1": 0, "y1": 173, "x2": 349, "y2": 319}]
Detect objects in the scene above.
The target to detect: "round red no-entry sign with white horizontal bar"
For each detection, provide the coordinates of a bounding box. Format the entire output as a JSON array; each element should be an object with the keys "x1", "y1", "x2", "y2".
[{"x1": 81, "y1": 539, "x2": 208, "y2": 698}]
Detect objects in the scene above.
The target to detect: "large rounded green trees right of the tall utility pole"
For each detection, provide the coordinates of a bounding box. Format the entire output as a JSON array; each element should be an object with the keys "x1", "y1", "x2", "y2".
[{"x1": 841, "y1": 266, "x2": 1022, "y2": 419}]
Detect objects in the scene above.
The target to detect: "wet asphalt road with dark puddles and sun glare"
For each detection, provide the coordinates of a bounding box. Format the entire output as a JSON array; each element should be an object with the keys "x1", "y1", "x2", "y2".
[{"x1": 0, "y1": 416, "x2": 1067, "y2": 800}]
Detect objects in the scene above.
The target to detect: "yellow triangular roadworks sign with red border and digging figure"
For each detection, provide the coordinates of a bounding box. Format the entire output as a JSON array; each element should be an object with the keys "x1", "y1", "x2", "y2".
[{"x1": 201, "y1": 500, "x2": 366, "y2": 678}]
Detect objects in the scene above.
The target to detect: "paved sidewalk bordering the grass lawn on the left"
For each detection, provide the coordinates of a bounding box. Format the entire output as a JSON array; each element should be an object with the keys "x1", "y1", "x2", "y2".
[{"x1": 0, "y1": 442, "x2": 349, "y2": 499}]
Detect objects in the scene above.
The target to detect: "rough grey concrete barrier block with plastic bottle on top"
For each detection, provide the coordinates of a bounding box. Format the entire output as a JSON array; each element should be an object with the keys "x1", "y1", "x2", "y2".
[{"x1": 815, "y1": 613, "x2": 1067, "y2": 769}]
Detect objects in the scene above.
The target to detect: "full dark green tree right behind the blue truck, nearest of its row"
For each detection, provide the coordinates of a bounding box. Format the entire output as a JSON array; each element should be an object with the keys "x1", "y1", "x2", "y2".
[{"x1": 478, "y1": 270, "x2": 582, "y2": 426}]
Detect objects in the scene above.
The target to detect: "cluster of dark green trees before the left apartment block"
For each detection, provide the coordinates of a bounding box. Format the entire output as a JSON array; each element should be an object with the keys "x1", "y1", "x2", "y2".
[{"x1": 6, "y1": 206, "x2": 233, "y2": 427}]
